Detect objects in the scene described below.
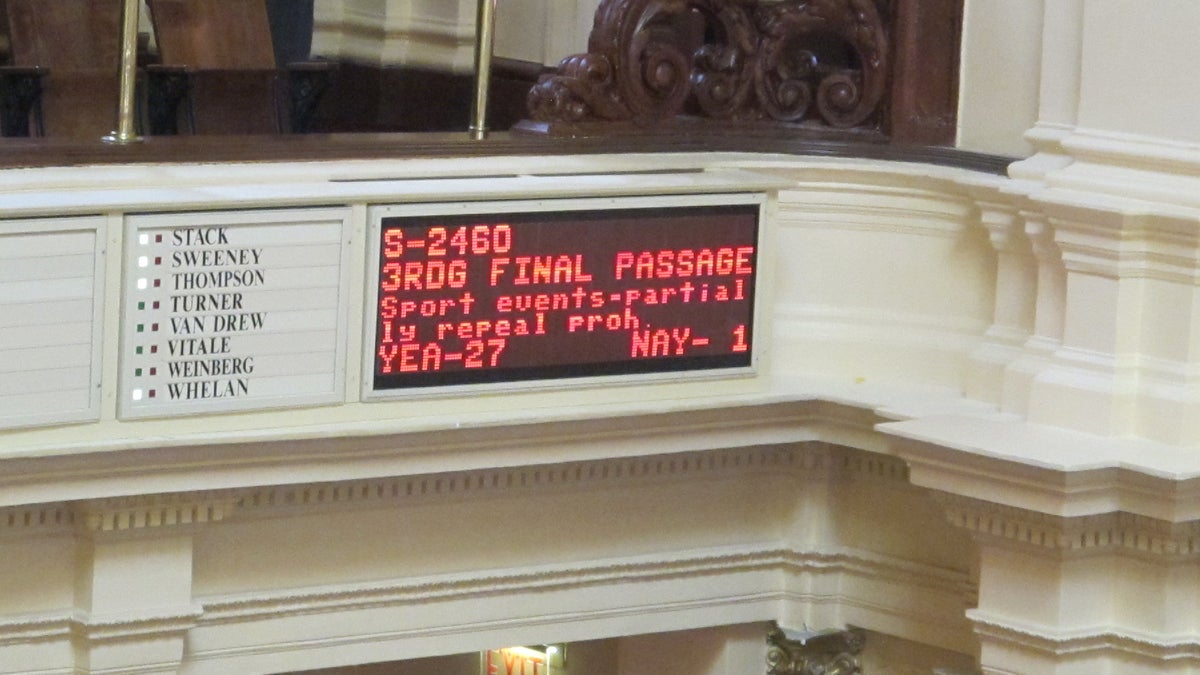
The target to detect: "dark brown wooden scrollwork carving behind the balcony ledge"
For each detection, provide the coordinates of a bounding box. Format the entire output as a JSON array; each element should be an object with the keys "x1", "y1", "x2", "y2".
[{"x1": 529, "y1": 0, "x2": 889, "y2": 130}]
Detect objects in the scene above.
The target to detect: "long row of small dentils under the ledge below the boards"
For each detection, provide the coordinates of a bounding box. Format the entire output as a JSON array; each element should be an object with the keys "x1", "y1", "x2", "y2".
[{"x1": 0, "y1": 442, "x2": 908, "y2": 537}]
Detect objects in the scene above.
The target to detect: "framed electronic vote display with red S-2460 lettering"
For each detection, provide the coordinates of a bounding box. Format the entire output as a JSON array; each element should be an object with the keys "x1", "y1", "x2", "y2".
[{"x1": 364, "y1": 195, "x2": 762, "y2": 399}]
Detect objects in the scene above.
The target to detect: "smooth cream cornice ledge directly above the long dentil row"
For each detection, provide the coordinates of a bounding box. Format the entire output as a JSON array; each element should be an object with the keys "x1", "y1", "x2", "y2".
[{"x1": 0, "y1": 398, "x2": 880, "y2": 506}]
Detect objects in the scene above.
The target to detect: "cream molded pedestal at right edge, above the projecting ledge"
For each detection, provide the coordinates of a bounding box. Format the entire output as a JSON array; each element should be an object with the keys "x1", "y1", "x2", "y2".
[{"x1": 1028, "y1": 203, "x2": 1200, "y2": 444}]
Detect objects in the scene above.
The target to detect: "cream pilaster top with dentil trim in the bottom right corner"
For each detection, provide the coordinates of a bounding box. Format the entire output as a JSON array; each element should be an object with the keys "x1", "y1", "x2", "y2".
[{"x1": 936, "y1": 494, "x2": 1200, "y2": 675}]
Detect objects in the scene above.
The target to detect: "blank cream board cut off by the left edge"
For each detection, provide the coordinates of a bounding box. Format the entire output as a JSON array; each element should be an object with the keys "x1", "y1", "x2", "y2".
[{"x1": 0, "y1": 217, "x2": 106, "y2": 429}]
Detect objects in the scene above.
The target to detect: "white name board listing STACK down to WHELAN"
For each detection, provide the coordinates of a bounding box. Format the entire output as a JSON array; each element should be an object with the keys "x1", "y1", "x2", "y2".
[{"x1": 120, "y1": 209, "x2": 350, "y2": 418}]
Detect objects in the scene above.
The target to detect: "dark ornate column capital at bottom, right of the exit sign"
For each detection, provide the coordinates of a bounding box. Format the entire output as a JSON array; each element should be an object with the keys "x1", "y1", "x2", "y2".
[{"x1": 767, "y1": 626, "x2": 866, "y2": 675}]
